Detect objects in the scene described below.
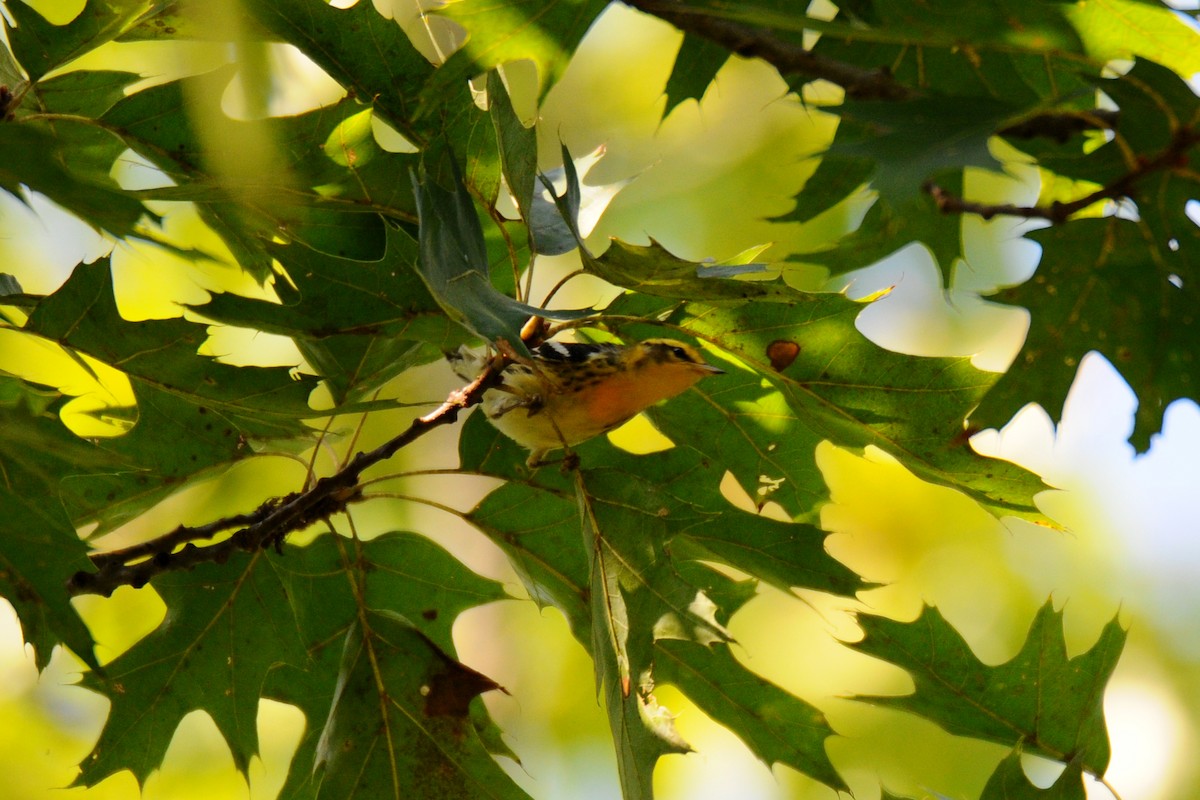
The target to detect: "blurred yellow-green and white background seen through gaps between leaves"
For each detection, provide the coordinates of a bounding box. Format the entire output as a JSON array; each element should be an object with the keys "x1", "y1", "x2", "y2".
[{"x1": 0, "y1": 0, "x2": 1200, "y2": 800}]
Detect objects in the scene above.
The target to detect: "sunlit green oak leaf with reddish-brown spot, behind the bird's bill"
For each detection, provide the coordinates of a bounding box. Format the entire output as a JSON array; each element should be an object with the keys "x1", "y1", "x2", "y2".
[{"x1": 606, "y1": 291, "x2": 1044, "y2": 519}]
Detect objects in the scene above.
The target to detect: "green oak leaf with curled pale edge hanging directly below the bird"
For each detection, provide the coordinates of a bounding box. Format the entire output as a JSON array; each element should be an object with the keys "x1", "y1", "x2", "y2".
[{"x1": 461, "y1": 419, "x2": 860, "y2": 796}]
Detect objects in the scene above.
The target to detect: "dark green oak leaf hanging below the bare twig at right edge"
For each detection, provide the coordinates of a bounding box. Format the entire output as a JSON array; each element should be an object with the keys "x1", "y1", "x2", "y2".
[{"x1": 971, "y1": 219, "x2": 1200, "y2": 450}]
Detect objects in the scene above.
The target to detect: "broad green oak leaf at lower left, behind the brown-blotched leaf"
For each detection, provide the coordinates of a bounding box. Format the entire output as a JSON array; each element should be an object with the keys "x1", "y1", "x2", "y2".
[{"x1": 80, "y1": 534, "x2": 504, "y2": 796}]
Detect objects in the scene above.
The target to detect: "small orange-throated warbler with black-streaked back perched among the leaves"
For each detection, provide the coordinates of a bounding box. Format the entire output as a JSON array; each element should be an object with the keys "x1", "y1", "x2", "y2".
[{"x1": 449, "y1": 339, "x2": 724, "y2": 467}]
